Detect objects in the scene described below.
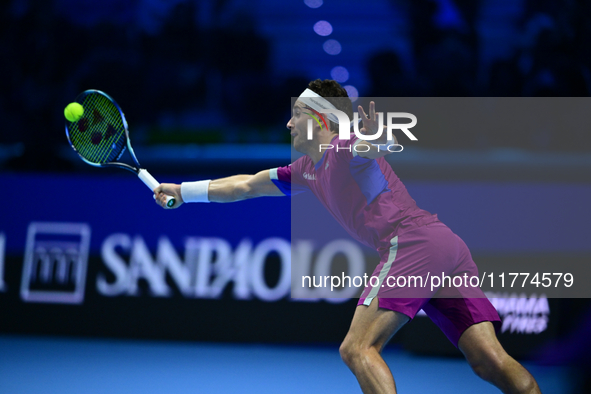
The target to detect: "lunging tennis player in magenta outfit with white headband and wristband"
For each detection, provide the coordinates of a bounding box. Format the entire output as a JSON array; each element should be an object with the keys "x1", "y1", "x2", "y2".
[{"x1": 154, "y1": 80, "x2": 540, "y2": 393}]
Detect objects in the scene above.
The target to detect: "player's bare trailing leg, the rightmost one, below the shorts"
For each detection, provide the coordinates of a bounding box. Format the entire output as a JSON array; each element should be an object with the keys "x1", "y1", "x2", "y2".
[{"x1": 458, "y1": 322, "x2": 540, "y2": 394}]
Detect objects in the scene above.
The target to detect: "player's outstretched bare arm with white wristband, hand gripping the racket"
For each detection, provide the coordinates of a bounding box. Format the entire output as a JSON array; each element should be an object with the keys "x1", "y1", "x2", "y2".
[{"x1": 154, "y1": 170, "x2": 284, "y2": 209}]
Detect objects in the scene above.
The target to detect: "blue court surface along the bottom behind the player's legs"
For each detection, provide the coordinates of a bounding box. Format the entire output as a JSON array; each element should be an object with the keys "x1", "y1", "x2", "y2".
[{"x1": 0, "y1": 335, "x2": 572, "y2": 394}]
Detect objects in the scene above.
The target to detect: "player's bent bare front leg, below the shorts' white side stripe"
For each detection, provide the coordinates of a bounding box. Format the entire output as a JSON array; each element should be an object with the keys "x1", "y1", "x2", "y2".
[{"x1": 339, "y1": 299, "x2": 409, "y2": 394}]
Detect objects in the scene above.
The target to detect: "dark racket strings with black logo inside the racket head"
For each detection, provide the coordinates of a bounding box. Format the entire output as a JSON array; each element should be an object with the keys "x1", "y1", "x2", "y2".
[{"x1": 69, "y1": 92, "x2": 127, "y2": 164}]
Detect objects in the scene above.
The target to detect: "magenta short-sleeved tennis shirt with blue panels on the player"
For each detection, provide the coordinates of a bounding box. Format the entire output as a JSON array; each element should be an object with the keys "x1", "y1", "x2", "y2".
[{"x1": 270, "y1": 134, "x2": 439, "y2": 255}]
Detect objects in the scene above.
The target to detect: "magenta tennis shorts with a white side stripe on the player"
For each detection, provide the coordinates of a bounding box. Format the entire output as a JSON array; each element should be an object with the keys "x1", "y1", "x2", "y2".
[{"x1": 358, "y1": 222, "x2": 501, "y2": 347}]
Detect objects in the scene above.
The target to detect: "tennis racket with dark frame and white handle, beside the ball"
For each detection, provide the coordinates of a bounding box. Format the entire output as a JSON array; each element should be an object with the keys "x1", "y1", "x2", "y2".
[{"x1": 66, "y1": 90, "x2": 175, "y2": 207}]
